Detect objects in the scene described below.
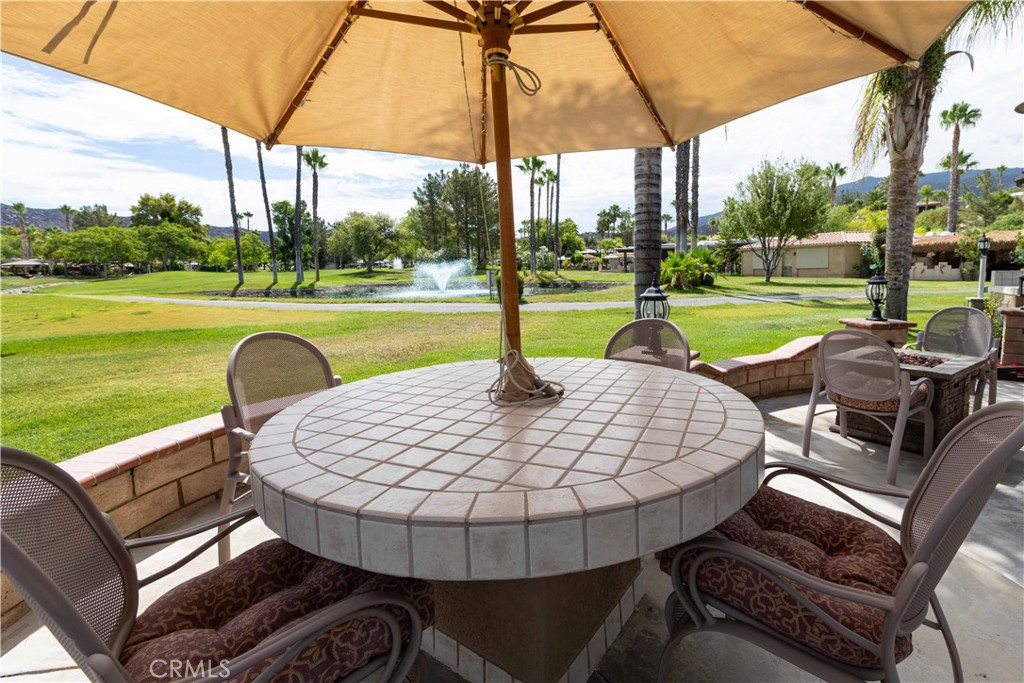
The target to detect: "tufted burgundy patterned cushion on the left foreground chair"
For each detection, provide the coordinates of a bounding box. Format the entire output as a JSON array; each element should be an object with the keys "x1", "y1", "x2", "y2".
[{"x1": 121, "y1": 540, "x2": 433, "y2": 682}]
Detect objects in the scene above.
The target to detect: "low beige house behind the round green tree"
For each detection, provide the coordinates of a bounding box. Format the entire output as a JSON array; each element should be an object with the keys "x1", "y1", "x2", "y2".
[{"x1": 739, "y1": 232, "x2": 871, "y2": 278}]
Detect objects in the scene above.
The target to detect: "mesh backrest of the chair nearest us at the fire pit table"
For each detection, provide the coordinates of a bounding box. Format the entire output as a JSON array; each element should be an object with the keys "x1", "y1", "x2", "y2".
[{"x1": 818, "y1": 330, "x2": 900, "y2": 401}]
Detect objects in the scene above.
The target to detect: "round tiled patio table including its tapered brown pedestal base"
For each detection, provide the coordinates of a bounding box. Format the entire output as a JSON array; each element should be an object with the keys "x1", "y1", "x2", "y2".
[{"x1": 250, "y1": 358, "x2": 764, "y2": 683}]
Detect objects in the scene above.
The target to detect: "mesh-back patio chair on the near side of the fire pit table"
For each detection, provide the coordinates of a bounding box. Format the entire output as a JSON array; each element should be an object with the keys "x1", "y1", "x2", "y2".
[{"x1": 803, "y1": 330, "x2": 935, "y2": 484}]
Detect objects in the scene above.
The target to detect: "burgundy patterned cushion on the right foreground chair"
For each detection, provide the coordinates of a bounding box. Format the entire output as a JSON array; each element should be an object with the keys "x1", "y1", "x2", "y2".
[{"x1": 660, "y1": 486, "x2": 912, "y2": 667}]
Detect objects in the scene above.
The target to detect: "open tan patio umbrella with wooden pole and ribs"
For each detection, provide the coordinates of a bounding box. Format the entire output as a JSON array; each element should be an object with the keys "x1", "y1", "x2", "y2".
[{"x1": 0, "y1": 0, "x2": 969, "y2": 398}]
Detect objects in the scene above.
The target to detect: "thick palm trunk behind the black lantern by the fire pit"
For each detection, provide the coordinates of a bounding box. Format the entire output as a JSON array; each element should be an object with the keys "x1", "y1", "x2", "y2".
[{"x1": 885, "y1": 69, "x2": 936, "y2": 321}]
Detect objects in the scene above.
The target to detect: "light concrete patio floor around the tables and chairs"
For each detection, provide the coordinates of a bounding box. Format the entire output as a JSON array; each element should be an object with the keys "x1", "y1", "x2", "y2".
[{"x1": 0, "y1": 382, "x2": 1024, "y2": 683}]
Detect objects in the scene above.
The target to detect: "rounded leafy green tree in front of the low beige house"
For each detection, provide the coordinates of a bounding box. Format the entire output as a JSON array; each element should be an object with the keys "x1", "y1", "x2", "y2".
[{"x1": 719, "y1": 161, "x2": 828, "y2": 283}]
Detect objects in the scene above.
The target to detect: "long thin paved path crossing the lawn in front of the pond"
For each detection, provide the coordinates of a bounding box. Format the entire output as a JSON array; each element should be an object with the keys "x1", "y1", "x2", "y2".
[{"x1": 68, "y1": 292, "x2": 867, "y2": 313}]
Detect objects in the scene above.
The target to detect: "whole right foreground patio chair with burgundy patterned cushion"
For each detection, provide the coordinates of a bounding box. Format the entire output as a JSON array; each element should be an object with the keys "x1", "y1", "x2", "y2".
[{"x1": 659, "y1": 403, "x2": 1024, "y2": 683}]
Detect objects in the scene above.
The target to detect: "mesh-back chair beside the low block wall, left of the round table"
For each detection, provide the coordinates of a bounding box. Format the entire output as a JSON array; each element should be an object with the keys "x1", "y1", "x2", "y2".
[{"x1": 218, "y1": 332, "x2": 341, "y2": 563}]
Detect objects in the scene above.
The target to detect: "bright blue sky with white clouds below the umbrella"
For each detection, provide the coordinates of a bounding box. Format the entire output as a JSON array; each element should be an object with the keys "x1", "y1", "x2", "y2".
[{"x1": 0, "y1": 37, "x2": 1024, "y2": 230}]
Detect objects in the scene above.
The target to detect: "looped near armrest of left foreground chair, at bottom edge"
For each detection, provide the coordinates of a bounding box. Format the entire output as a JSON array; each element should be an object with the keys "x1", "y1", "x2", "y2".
[{"x1": 185, "y1": 592, "x2": 423, "y2": 683}]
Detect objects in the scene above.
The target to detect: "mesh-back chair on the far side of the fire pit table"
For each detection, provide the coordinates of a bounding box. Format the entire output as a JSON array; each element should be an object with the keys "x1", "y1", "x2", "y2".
[{"x1": 903, "y1": 306, "x2": 999, "y2": 411}]
